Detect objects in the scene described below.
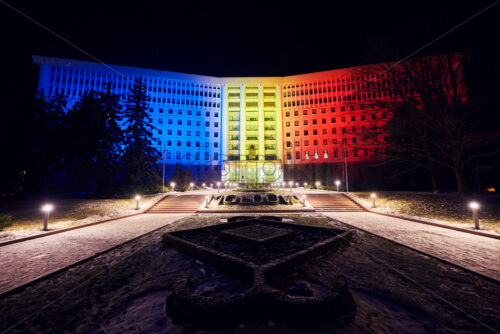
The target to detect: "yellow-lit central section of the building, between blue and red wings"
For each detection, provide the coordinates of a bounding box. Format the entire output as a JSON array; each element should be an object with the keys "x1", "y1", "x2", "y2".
[{"x1": 222, "y1": 78, "x2": 282, "y2": 184}]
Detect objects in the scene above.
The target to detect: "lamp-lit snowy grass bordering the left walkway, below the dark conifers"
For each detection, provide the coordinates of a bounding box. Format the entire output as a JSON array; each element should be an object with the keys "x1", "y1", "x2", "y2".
[{"x1": 0, "y1": 195, "x2": 154, "y2": 232}]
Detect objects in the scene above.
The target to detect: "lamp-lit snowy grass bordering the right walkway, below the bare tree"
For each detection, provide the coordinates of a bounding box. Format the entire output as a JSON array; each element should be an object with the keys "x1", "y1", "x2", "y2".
[{"x1": 352, "y1": 191, "x2": 500, "y2": 233}]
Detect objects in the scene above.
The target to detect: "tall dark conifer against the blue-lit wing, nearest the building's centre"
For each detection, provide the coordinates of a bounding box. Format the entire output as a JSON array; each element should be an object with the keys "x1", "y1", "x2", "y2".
[{"x1": 122, "y1": 79, "x2": 160, "y2": 191}]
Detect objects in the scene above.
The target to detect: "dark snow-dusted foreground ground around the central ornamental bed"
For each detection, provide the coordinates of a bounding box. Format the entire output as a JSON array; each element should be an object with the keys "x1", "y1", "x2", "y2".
[{"x1": 0, "y1": 216, "x2": 500, "y2": 333}]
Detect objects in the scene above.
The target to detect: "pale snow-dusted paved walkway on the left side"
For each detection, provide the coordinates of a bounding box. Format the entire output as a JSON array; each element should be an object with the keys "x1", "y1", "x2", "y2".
[{"x1": 0, "y1": 214, "x2": 187, "y2": 294}]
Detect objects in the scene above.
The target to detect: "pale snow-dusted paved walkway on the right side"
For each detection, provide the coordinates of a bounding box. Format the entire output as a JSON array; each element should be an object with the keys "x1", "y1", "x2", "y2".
[{"x1": 323, "y1": 212, "x2": 500, "y2": 281}]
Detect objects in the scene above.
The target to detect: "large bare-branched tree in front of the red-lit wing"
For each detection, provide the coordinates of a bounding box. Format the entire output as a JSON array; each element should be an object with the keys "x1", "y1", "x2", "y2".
[{"x1": 363, "y1": 54, "x2": 500, "y2": 194}]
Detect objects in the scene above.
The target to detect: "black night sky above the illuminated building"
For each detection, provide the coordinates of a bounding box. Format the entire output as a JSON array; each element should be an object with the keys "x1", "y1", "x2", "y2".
[{"x1": 0, "y1": 0, "x2": 500, "y2": 112}]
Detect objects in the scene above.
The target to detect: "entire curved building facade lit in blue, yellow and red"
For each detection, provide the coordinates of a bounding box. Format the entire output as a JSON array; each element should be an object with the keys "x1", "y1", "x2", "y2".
[{"x1": 33, "y1": 56, "x2": 428, "y2": 183}]
